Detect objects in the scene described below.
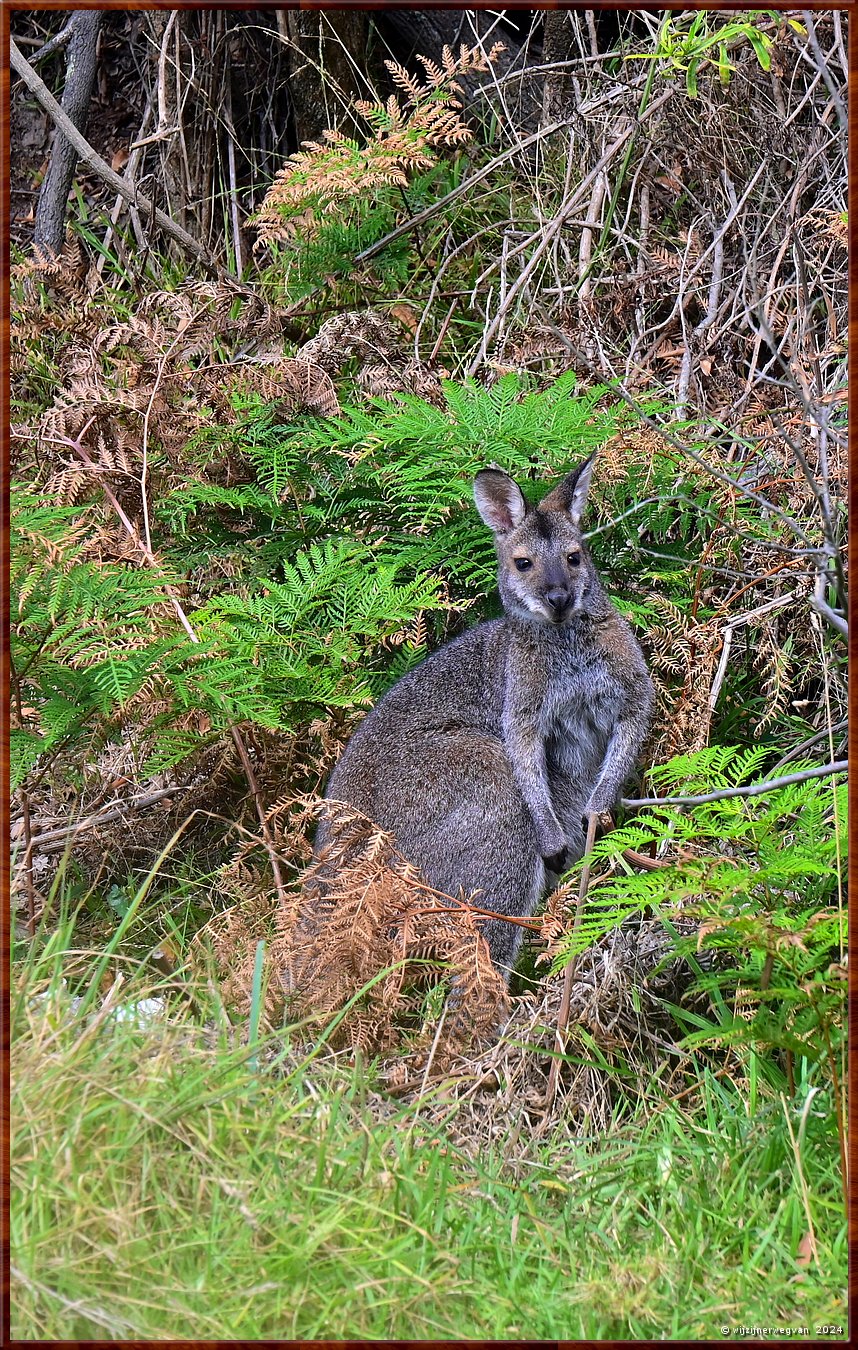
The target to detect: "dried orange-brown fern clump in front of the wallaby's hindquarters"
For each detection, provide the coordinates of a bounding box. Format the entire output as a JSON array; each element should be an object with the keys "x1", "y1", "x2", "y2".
[{"x1": 194, "y1": 799, "x2": 509, "y2": 1064}]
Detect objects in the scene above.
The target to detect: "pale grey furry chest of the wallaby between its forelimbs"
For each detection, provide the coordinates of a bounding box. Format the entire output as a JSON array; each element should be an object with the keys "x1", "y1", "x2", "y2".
[{"x1": 542, "y1": 670, "x2": 619, "y2": 772}]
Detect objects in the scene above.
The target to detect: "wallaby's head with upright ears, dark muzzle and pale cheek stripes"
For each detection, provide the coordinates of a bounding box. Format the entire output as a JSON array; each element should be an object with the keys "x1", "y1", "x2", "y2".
[{"x1": 474, "y1": 455, "x2": 599, "y2": 626}]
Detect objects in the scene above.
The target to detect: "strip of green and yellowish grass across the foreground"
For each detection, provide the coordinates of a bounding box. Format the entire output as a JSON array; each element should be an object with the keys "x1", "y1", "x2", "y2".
[{"x1": 11, "y1": 930, "x2": 846, "y2": 1339}]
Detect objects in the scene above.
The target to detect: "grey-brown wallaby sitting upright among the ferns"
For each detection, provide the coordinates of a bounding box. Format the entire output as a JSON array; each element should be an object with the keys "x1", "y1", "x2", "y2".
[{"x1": 317, "y1": 456, "x2": 653, "y2": 980}]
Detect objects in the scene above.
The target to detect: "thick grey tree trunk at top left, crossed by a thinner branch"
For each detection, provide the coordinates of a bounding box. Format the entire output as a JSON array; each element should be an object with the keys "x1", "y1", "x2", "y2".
[{"x1": 34, "y1": 9, "x2": 101, "y2": 254}]
